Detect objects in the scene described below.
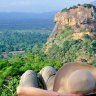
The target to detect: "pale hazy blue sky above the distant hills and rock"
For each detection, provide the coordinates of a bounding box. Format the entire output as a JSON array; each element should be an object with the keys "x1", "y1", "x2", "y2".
[{"x1": 0, "y1": 0, "x2": 94, "y2": 13}]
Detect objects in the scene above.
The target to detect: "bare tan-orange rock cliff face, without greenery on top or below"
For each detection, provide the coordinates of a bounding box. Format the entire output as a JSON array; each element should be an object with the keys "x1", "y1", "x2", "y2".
[{"x1": 48, "y1": 5, "x2": 96, "y2": 42}]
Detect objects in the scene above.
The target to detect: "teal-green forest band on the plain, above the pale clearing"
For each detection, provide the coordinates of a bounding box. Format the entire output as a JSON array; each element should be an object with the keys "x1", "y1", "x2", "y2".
[{"x1": 0, "y1": 29, "x2": 50, "y2": 52}]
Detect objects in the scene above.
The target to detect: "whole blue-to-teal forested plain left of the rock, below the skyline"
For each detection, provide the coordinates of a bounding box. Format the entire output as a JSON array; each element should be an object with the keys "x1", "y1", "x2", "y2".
[{"x1": 0, "y1": 13, "x2": 54, "y2": 59}]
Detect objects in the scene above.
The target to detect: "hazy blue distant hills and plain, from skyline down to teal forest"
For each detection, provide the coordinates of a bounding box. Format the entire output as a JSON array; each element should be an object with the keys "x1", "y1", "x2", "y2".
[{"x1": 0, "y1": 12, "x2": 56, "y2": 29}]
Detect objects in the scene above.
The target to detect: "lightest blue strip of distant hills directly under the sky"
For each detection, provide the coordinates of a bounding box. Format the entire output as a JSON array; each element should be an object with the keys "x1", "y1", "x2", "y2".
[{"x1": 0, "y1": 12, "x2": 56, "y2": 20}]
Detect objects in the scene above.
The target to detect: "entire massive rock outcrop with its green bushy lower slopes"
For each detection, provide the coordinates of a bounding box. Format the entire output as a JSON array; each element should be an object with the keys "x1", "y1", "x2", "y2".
[{"x1": 44, "y1": 4, "x2": 96, "y2": 64}]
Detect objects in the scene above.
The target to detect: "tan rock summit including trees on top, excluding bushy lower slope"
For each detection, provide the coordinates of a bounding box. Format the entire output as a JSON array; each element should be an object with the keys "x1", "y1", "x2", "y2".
[{"x1": 45, "y1": 4, "x2": 96, "y2": 52}]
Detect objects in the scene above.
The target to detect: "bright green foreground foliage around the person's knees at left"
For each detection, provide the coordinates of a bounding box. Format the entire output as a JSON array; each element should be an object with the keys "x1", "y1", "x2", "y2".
[{"x1": 0, "y1": 50, "x2": 61, "y2": 96}]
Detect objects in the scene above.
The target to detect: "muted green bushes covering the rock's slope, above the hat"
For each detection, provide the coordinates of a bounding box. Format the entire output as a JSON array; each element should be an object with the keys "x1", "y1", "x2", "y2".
[{"x1": 47, "y1": 27, "x2": 96, "y2": 65}]
